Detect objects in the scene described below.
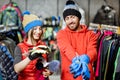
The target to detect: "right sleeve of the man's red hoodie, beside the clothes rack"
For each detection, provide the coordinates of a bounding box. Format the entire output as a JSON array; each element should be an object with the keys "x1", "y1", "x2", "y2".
[{"x1": 87, "y1": 32, "x2": 99, "y2": 62}]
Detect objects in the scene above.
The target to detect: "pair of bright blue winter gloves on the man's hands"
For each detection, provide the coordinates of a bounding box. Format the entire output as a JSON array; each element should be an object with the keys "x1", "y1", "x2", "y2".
[{"x1": 70, "y1": 55, "x2": 90, "y2": 80}]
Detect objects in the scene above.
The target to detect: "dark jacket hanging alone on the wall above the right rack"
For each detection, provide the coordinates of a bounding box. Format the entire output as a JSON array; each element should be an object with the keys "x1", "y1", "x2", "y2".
[{"x1": 93, "y1": 5, "x2": 118, "y2": 26}]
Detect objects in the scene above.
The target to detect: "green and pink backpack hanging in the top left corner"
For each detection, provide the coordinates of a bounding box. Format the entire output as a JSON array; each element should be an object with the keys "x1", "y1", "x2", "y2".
[{"x1": 0, "y1": 2, "x2": 22, "y2": 31}]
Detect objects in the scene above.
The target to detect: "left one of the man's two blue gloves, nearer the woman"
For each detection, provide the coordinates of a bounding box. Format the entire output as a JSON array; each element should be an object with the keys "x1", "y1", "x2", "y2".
[{"x1": 70, "y1": 56, "x2": 82, "y2": 78}]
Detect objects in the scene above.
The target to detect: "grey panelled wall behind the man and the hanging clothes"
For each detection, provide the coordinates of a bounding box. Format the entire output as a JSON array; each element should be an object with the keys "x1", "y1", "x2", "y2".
[{"x1": 0, "y1": 0, "x2": 120, "y2": 25}]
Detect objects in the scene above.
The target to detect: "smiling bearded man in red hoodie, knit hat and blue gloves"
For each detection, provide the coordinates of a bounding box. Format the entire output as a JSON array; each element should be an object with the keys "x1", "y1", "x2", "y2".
[{"x1": 57, "y1": 0, "x2": 98, "y2": 80}]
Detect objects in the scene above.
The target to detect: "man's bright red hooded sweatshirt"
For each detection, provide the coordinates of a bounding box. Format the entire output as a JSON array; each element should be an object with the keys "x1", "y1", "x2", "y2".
[{"x1": 57, "y1": 25, "x2": 98, "y2": 80}]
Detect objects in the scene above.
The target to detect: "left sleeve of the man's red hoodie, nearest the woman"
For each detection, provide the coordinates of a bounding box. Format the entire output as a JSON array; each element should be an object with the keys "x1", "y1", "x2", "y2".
[{"x1": 57, "y1": 30, "x2": 75, "y2": 61}]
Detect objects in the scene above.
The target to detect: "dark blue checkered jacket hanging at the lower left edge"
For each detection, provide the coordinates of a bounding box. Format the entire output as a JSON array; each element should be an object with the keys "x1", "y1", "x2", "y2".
[{"x1": 0, "y1": 43, "x2": 17, "y2": 80}]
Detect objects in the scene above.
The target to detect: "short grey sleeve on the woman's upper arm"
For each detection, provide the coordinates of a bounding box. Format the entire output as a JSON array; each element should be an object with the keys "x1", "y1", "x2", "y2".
[{"x1": 13, "y1": 46, "x2": 22, "y2": 65}]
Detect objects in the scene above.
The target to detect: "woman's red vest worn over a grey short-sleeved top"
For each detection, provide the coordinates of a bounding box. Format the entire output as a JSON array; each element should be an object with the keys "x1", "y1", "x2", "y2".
[{"x1": 18, "y1": 39, "x2": 45, "y2": 80}]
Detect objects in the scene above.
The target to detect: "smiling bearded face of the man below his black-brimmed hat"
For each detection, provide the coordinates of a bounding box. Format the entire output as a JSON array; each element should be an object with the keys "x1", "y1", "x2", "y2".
[{"x1": 65, "y1": 15, "x2": 79, "y2": 31}]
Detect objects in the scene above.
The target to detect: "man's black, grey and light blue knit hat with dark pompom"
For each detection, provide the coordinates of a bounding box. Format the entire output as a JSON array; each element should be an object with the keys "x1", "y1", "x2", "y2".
[{"x1": 63, "y1": 0, "x2": 81, "y2": 19}]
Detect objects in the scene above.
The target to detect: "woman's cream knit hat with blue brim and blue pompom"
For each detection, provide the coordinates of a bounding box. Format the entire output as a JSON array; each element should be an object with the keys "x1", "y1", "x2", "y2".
[{"x1": 22, "y1": 11, "x2": 43, "y2": 33}]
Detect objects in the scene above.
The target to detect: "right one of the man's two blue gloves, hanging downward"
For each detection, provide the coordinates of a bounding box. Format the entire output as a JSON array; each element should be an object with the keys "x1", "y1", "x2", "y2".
[{"x1": 80, "y1": 54, "x2": 90, "y2": 80}]
